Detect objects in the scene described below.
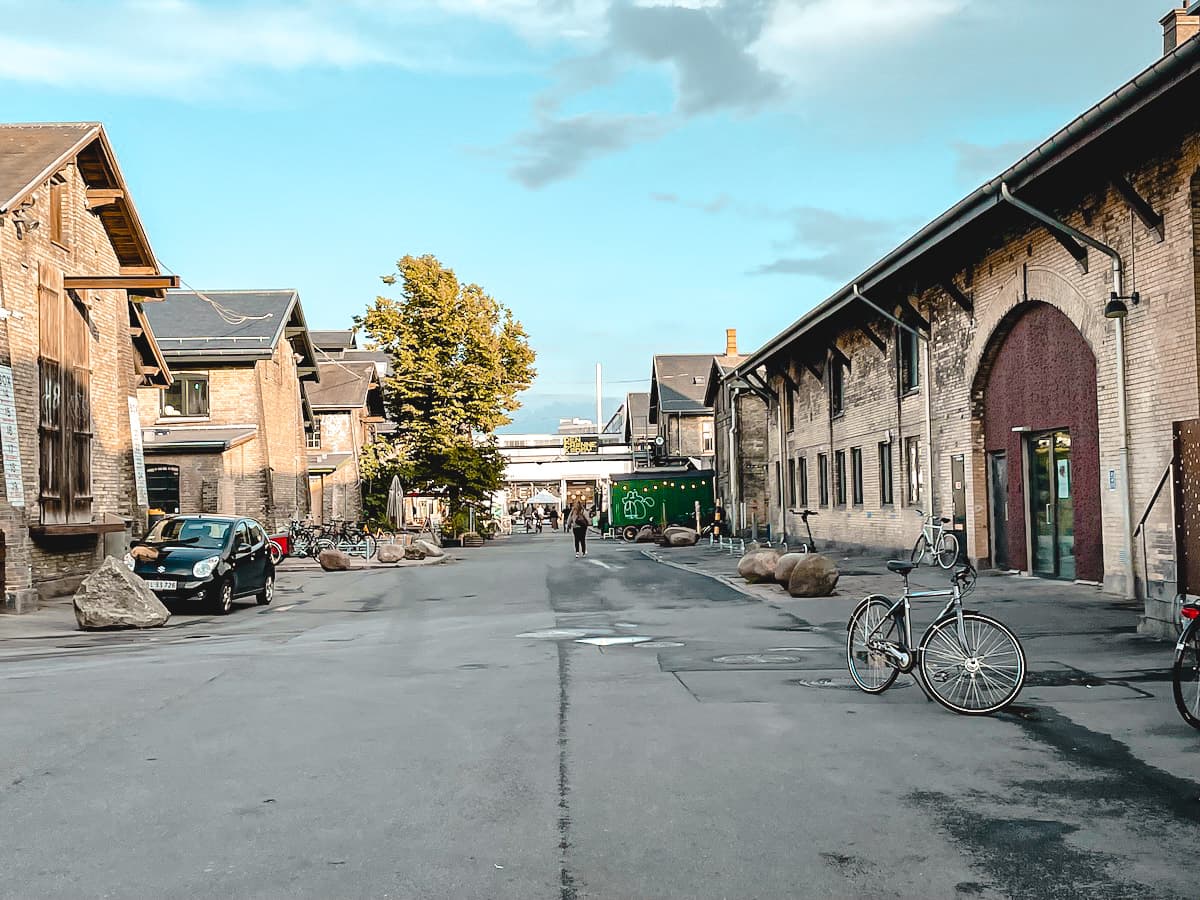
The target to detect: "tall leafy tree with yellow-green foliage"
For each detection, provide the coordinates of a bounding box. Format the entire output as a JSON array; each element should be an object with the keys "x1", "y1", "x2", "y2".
[{"x1": 355, "y1": 256, "x2": 536, "y2": 517}]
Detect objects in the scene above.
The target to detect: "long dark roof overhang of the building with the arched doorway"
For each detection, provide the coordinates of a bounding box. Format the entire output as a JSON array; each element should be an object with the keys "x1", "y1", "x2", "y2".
[{"x1": 734, "y1": 33, "x2": 1200, "y2": 374}]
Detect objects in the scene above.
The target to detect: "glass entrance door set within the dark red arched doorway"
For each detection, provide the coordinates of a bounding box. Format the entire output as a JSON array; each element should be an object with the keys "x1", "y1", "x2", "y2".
[{"x1": 1030, "y1": 431, "x2": 1075, "y2": 578}]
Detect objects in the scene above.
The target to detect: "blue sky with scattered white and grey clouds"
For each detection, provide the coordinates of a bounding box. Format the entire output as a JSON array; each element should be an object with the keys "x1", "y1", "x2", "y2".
[{"x1": 0, "y1": 0, "x2": 1172, "y2": 431}]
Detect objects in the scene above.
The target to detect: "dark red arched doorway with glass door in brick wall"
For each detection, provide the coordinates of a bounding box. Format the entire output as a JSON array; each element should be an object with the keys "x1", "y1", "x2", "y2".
[{"x1": 976, "y1": 302, "x2": 1104, "y2": 581}]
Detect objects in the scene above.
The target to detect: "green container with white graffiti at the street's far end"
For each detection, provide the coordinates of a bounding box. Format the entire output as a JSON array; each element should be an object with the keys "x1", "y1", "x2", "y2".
[{"x1": 608, "y1": 468, "x2": 716, "y2": 540}]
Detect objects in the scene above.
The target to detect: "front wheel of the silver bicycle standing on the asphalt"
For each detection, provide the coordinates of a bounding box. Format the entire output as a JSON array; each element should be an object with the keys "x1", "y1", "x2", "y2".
[{"x1": 920, "y1": 612, "x2": 1025, "y2": 715}]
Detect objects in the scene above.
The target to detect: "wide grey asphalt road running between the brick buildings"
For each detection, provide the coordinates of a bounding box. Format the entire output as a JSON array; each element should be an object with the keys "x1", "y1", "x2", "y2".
[{"x1": 0, "y1": 533, "x2": 1200, "y2": 900}]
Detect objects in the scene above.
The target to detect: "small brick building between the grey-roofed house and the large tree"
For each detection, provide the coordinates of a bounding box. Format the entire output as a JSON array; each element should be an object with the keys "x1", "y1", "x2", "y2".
[{"x1": 306, "y1": 359, "x2": 386, "y2": 522}]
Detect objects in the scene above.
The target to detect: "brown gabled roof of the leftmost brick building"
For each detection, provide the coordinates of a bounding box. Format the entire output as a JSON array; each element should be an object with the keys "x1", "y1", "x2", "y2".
[{"x1": 0, "y1": 122, "x2": 160, "y2": 275}]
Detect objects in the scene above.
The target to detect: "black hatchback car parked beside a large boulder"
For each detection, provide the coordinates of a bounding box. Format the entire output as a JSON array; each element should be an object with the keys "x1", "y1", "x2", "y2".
[{"x1": 125, "y1": 516, "x2": 275, "y2": 616}]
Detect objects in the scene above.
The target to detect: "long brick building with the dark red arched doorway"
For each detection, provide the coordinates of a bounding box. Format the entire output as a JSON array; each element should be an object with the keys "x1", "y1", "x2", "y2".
[{"x1": 730, "y1": 10, "x2": 1200, "y2": 634}]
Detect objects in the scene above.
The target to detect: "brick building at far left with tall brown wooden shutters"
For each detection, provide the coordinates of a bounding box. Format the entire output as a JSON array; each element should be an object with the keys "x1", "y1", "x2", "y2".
[{"x1": 0, "y1": 122, "x2": 175, "y2": 612}]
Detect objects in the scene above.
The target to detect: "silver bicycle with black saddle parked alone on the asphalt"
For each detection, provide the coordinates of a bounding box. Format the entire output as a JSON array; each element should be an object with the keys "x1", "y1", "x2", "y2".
[{"x1": 846, "y1": 559, "x2": 1025, "y2": 715}]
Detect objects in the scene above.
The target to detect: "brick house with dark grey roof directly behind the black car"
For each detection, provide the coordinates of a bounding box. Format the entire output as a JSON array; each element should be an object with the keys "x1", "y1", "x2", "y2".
[{"x1": 138, "y1": 290, "x2": 319, "y2": 530}]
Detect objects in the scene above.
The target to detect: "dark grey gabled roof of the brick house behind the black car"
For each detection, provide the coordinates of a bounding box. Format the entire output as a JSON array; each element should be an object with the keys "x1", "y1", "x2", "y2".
[{"x1": 145, "y1": 290, "x2": 319, "y2": 380}]
